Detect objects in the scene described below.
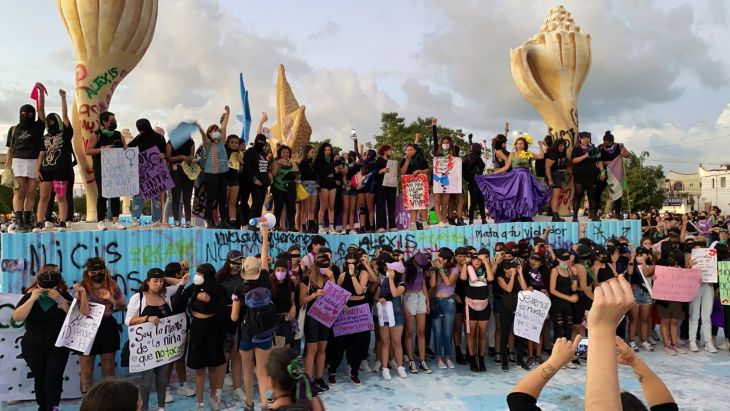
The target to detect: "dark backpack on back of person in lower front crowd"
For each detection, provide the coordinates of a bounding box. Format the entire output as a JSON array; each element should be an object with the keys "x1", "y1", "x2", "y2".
[{"x1": 241, "y1": 287, "x2": 279, "y2": 343}]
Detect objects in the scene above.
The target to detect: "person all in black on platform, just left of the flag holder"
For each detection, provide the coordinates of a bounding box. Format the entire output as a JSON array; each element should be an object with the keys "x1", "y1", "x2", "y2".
[{"x1": 571, "y1": 131, "x2": 606, "y2": 222}]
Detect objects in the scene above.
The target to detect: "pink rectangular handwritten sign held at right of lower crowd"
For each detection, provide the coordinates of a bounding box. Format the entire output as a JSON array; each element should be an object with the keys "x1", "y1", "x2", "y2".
[{"x1": 651, "y1": 265, "x2": 702, "y2": 303}]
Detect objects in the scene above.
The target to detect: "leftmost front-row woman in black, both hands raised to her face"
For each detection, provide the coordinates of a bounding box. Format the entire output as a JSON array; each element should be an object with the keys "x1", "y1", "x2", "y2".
[{"x1": 12, "y1": 264, "x2": 84, "y2": 411}]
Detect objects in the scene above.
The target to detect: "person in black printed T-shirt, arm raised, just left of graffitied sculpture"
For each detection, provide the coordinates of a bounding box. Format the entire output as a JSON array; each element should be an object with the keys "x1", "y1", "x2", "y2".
[{"x1": 36, "y1": 90, "x2": 74, "y2": 231}]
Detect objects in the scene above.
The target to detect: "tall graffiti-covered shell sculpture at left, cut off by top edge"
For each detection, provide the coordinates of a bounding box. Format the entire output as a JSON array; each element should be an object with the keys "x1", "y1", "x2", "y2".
[{"x1": 56, "y1": 0, "x2": 158, "y2": 221}]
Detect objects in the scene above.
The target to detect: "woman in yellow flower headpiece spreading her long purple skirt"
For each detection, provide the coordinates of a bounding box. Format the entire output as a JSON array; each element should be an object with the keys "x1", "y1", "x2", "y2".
[{"x1": 475, "y1": 134, "x2": 551, "y2": 223}]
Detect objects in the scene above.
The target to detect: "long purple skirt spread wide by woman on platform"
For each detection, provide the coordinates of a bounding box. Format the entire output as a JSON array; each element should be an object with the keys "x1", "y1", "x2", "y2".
[{"x1": 476, "y1": 168, "x2": 552, "y2": 223}]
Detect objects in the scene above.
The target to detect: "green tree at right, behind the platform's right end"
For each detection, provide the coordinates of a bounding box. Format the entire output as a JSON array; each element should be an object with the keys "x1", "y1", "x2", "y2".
[{"x1": 624, "y1": 151, "x2": 667, "y2": 211}]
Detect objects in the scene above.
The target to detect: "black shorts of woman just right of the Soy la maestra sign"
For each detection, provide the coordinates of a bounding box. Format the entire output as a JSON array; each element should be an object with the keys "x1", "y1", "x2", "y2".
[{"x1": 187, "y1": 317, "x2": 226, "y2": 370}]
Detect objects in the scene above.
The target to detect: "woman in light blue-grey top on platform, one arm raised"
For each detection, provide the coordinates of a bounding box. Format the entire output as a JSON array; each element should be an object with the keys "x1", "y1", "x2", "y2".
[{"x1": 200, "y1": 106, "x2": 231, "y2": 228}]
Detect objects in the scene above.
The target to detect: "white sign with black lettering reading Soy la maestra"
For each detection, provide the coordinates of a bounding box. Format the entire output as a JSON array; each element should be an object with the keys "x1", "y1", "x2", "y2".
[{"x1": 129, "y1": 313, "x2": 187, "y2": 372}]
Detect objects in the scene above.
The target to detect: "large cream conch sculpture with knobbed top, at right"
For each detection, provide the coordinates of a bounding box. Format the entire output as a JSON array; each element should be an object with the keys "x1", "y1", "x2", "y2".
[{"x1": 510, "y1": 6, "x2": 591, "y2": 151}]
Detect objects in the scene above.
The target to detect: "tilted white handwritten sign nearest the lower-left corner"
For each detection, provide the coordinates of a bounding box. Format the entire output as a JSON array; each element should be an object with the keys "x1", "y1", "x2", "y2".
[{"x1": 56, "y1": 299, "x2": 104, "y2": 355}]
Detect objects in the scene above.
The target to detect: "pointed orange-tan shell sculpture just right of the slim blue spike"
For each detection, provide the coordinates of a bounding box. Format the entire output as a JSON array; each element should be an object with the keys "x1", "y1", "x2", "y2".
[{"x1": 270, "y1": 64, "x2": 312, "y2": 160}]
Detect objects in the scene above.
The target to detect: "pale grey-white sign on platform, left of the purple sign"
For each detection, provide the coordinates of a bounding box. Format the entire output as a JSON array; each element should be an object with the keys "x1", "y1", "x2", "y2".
[{"x1": 101, "y1": 147, "x2": 139, "y2": 198}]
